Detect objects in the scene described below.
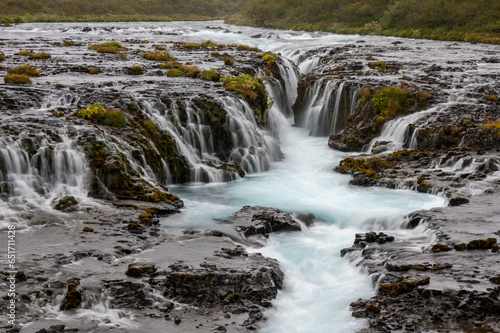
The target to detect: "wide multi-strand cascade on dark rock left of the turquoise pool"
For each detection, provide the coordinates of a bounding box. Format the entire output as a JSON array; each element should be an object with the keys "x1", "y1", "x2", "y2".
[{"x1": 141, "y1": 97, "x2": 281, "y2": 183}]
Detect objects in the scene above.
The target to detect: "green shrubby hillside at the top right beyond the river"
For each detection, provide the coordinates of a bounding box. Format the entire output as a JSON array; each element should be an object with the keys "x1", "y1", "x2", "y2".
[{"x1": 228, "y1": 0, "x2": 500, "y2": 44}]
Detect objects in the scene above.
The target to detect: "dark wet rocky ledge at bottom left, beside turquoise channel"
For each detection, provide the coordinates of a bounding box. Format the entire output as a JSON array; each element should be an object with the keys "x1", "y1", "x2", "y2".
[{"x1": 0, "y1": 201, "x2": 301, "y2": 333}]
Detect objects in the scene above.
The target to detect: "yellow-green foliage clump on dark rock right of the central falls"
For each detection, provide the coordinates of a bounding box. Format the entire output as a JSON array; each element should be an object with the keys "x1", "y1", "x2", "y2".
[{"x1": 371, "y1": 87, "x2": 414, "y2": 120}]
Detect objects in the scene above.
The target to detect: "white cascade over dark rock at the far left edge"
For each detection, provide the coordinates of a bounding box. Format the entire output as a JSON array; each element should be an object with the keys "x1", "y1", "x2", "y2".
[{"x1": 0, "y1": 133, "x2": 89, "y2": 227}]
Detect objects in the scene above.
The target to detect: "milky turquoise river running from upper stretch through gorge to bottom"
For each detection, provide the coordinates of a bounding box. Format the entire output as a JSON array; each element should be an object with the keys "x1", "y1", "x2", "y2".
[{"x1": 2, "y1": 22, "x2": 487, "y2": 333}]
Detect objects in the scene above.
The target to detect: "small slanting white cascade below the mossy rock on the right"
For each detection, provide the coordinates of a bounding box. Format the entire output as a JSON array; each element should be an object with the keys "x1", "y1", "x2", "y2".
[{"x1": 363, "y1": 106, "x2": 440, "y2": 153}]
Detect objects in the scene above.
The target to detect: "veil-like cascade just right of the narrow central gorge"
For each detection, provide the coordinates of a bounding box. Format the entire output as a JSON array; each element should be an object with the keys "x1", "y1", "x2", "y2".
[{"x1": 294, "y1": 78, "x2": 357, "y2": 136}]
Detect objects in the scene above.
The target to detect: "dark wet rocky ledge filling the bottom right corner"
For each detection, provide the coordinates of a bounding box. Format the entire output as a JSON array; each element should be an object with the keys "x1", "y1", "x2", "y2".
[{"x1": 342, "y1": 193, "x2": 500, "y2": 332}]
